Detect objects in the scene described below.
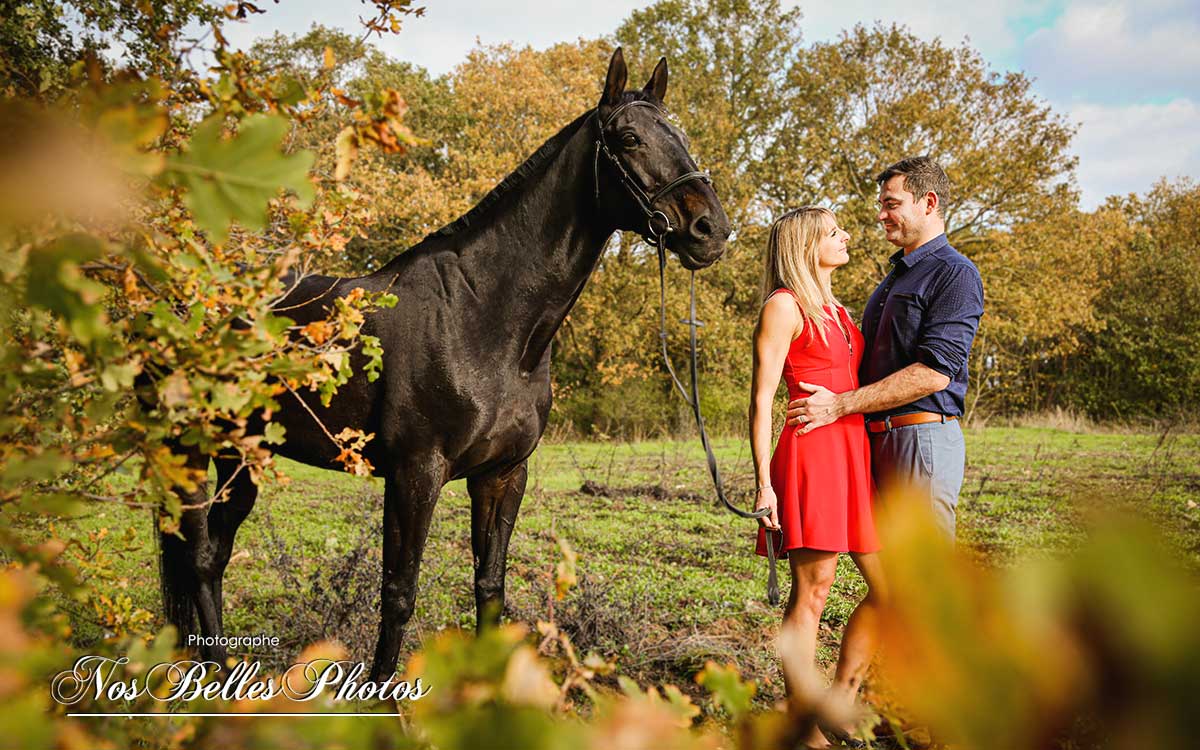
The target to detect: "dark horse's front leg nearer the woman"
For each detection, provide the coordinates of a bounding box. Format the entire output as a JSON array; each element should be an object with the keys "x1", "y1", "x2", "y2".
[{"x1": 467, "y1": 461, "x2": 528, "y2": 632}]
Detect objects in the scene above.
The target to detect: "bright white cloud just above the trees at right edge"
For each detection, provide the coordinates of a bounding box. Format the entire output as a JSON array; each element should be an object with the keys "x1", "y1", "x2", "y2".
[{"x1": 1069, "y1": 98, "x2": 1200, "y2": 209}]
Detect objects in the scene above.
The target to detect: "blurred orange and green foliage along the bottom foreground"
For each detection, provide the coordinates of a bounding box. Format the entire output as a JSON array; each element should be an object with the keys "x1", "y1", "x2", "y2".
[{"x1": 0, "y1": 498, "x2": 1200, "y2": 750}]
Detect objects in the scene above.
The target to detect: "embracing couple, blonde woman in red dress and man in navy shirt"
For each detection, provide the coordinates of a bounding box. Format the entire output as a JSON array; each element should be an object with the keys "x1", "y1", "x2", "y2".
[{"x1": 750, "y1": 157, "x2": 983, "y2": 748}]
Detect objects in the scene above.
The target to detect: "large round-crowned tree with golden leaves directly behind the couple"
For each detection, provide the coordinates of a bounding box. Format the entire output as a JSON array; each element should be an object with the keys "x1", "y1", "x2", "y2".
[{"x1": 760, "y1": 25, "x2": 1076, "y2": 306}]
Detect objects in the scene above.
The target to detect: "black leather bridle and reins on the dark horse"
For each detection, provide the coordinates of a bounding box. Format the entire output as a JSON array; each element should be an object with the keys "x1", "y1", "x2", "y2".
[{"x1": 592, "y1": 100, "x2": 782, "y2": 605}]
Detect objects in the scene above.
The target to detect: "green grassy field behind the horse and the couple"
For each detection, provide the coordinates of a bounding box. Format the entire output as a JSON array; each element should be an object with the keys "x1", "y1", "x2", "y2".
[{"x1": 14, "y1": 427, "x2": 1200, "y2": 703}]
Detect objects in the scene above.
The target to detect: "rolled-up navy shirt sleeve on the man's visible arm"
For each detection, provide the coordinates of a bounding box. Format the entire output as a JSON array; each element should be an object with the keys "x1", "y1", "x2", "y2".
[{"x1": 917, "y1": 263, "x2": 983, "y2": 379}]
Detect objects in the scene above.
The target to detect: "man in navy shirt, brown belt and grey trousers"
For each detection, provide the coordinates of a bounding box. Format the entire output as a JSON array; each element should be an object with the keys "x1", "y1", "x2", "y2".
[{"x1": 787, "y1": 156, "x2": 983, "y2": 540}]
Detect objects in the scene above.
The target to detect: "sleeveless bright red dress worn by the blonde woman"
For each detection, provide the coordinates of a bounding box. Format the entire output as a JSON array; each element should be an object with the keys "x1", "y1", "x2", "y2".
[{"x1": 756, "y1": 289, "x2": 880, "y2": 557}]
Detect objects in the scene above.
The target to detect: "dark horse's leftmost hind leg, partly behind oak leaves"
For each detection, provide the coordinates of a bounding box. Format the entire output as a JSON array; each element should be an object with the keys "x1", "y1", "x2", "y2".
[{"x1": 158, "y1": 446, "x2": 226, "y2": 661}]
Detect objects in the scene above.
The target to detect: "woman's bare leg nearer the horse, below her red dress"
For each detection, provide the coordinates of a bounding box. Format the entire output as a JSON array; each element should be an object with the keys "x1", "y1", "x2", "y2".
[{"x1": 784, "y1": 550, "x2": 838, "y2": 748}]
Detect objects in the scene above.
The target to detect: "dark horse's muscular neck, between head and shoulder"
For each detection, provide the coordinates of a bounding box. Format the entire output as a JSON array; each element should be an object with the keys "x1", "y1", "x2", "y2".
[{"x1": 460, "y1": 121, "x2": 614, "y2": 372}]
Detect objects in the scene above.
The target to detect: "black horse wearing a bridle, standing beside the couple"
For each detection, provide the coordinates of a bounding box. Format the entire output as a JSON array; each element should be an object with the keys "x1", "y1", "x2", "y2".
[{"x1": 161, "y1": 49, "x2": 730, "y2": 679}]
